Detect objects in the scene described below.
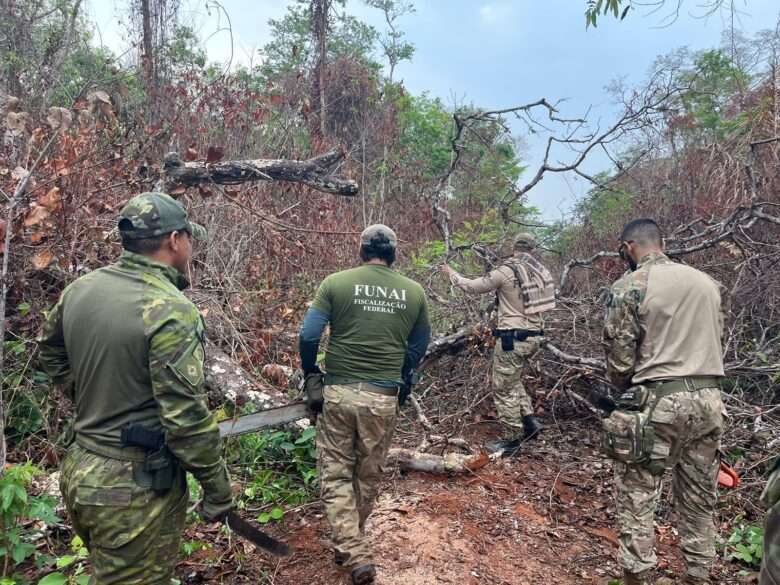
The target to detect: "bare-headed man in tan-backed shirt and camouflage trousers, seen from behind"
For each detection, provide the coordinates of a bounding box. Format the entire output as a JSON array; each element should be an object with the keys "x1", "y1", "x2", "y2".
[{"x1": 604, "y1": 219, "x2": 724, "y2": 585}]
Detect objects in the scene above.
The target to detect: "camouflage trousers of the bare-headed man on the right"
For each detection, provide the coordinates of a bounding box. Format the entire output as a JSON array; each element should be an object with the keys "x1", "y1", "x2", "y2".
[{"x1": 615, "y1": 388, "x2": 723, "y2": 578}]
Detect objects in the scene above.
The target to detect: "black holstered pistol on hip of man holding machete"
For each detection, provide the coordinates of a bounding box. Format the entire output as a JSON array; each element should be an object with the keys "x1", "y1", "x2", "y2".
[{"x1": 121, "y1": 423, "x2": 177, "y2": 493}]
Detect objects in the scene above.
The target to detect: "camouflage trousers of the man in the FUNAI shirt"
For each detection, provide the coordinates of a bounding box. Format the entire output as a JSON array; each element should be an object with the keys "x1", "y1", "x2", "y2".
[{"x1": 317, "y1": 384, "x2": 398, "y2": 570}]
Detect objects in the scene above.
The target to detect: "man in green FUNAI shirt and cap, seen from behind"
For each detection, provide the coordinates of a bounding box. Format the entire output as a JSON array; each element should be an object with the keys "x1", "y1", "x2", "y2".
[{"x1": 300, "y1": 224, "x2": 430, "y2": 585}]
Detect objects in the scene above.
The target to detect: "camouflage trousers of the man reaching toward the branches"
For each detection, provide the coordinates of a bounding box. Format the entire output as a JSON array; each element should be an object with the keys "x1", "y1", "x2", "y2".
[{"x1": 492, "y1": 337, "x2": 542, "y2": 435}]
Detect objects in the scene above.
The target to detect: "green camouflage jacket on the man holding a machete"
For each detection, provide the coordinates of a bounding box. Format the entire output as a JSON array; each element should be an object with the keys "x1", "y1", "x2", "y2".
[{"x1": 39, "y1": 252, "x2": 229, "y2": 495}]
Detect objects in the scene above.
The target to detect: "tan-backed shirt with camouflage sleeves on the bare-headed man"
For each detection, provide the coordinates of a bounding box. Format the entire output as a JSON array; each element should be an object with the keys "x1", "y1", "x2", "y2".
[{"x1": 603, "y1": 253, "x2": 723, "y2": 389}]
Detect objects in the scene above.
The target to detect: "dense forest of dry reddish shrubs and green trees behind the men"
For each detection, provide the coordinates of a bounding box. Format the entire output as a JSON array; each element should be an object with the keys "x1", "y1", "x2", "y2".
[{"x1": 0, "y1": 0, "x2": 780, "y2": 583}]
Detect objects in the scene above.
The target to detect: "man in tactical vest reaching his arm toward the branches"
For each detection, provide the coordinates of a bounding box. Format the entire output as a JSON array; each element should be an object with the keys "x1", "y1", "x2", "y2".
[{"x1": 442, "y1": 233, "x2": 555, "y2": 455}]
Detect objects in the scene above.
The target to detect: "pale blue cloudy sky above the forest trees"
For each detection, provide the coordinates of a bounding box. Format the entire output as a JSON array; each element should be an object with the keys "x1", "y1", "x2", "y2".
[{"x1": 88, "y1": 0, "x2": 780, "y2": 220}]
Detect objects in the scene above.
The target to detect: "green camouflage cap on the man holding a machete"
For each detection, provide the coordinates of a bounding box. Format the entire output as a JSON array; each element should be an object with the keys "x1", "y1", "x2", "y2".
[{"x1": 119, "y1": 193, "x2": 207, "y2": 240}]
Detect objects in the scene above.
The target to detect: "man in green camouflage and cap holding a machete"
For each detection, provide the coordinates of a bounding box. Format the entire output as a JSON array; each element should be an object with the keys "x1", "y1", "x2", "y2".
[{"x1": 39, "y1": 193, "x2": 232, "y2": 585}]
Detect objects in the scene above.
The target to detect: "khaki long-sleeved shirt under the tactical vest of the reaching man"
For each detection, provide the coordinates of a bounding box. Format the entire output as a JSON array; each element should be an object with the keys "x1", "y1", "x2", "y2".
[{"x1": 451, "y1": 266, "x2": 542, "y2": 331}]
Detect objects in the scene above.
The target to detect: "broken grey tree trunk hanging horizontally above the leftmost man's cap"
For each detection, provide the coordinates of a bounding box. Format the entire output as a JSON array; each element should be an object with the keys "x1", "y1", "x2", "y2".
[{"x1": 162, "y1": 151, "x2": 359, "y2": 197}]
